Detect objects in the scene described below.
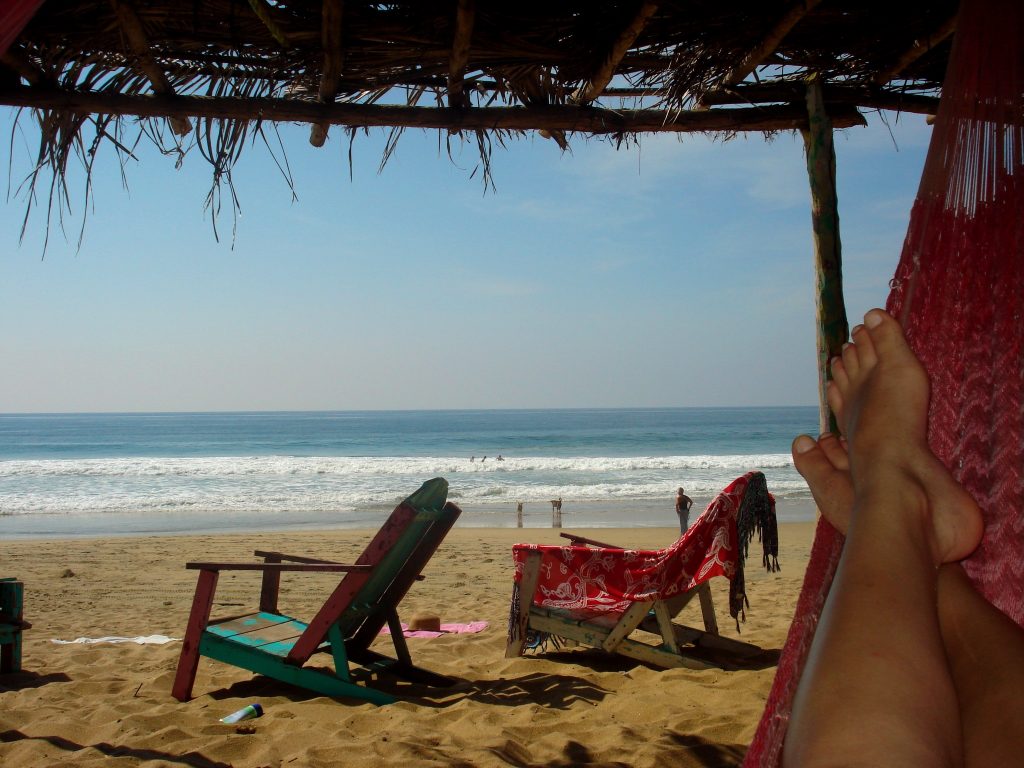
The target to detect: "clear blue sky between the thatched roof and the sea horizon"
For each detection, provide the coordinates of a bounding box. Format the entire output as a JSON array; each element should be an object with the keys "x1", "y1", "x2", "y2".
[{"x1": 0, "y1": 108, "x2": 931, "y2": 413}]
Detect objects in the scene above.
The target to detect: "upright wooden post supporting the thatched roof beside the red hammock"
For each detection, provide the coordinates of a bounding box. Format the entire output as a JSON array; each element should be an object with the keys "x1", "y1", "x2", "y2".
[{"x1": 803, "y1": 76, "x2": 850, "y2": 434}]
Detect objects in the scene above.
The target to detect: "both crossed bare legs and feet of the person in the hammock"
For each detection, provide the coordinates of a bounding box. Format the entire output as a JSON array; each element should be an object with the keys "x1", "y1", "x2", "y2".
[{"x1": 782, "y1": 309, "x2": 1024, "y2": 768}]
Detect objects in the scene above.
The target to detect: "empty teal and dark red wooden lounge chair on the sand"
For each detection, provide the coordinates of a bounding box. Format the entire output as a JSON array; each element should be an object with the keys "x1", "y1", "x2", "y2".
[{"x1": 172, "y1": 478, "x2": 461, "y2": 703}]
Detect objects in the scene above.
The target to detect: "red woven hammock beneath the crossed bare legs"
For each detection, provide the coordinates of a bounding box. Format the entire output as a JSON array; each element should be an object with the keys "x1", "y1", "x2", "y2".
[{"x1": 743, "y1": 0, "x2": 1024, "y2": 768}]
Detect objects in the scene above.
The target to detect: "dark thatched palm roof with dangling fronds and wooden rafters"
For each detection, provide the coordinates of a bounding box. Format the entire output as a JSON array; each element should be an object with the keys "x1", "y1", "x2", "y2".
[{"x1": 0, "y1": 0, "x2": 957, "y2": 231}]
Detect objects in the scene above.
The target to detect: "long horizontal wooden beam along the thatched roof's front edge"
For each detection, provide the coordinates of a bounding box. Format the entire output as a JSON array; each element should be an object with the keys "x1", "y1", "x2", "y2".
[{"x1": 0, "y1": 86, "x2": 866, "y2": 134}]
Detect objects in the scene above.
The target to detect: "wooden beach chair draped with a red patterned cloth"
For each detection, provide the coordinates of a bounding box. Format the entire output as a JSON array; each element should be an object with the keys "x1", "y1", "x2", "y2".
[{"x1": 505, "y1": 472, "x2": 778, "y2": 669}]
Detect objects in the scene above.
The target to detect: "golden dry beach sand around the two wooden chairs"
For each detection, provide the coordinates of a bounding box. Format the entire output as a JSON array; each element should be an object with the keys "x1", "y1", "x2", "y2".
[{"x1": 0, "y1": 523, "x2": 813, "y2": 768}]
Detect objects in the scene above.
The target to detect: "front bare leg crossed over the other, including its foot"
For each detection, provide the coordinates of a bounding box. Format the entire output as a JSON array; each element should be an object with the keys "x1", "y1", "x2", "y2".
[{"x1": 783, "y1": 310, "x2": 981, "y2": 766}]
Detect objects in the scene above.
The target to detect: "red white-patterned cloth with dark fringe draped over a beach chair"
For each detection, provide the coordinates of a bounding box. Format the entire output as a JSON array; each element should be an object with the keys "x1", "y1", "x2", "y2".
[{"x1": 512, "y1": 472, "x2": 778, "y2": 625}]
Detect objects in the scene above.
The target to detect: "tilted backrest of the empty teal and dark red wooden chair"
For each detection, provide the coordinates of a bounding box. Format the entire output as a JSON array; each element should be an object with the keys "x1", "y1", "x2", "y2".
[{"x1": 289, "y1": 477, "x2": 461, "y2": 664}]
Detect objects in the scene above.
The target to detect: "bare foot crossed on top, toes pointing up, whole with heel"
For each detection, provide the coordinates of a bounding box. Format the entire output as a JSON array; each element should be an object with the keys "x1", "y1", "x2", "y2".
[{"x1": 827, "y1": 309, "x2": 982, "y2": 564}]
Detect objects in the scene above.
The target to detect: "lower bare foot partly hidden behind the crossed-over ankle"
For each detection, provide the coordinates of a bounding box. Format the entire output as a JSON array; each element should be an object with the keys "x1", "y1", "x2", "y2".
[{"x1": 793, "y1": 432, "x2": 853, "y2": 535}]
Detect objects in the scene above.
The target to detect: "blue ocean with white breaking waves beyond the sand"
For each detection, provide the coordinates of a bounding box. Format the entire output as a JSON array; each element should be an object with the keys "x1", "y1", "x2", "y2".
[{"x1": 0, "y1": 407, "x2": 817, "y2": 538}]
